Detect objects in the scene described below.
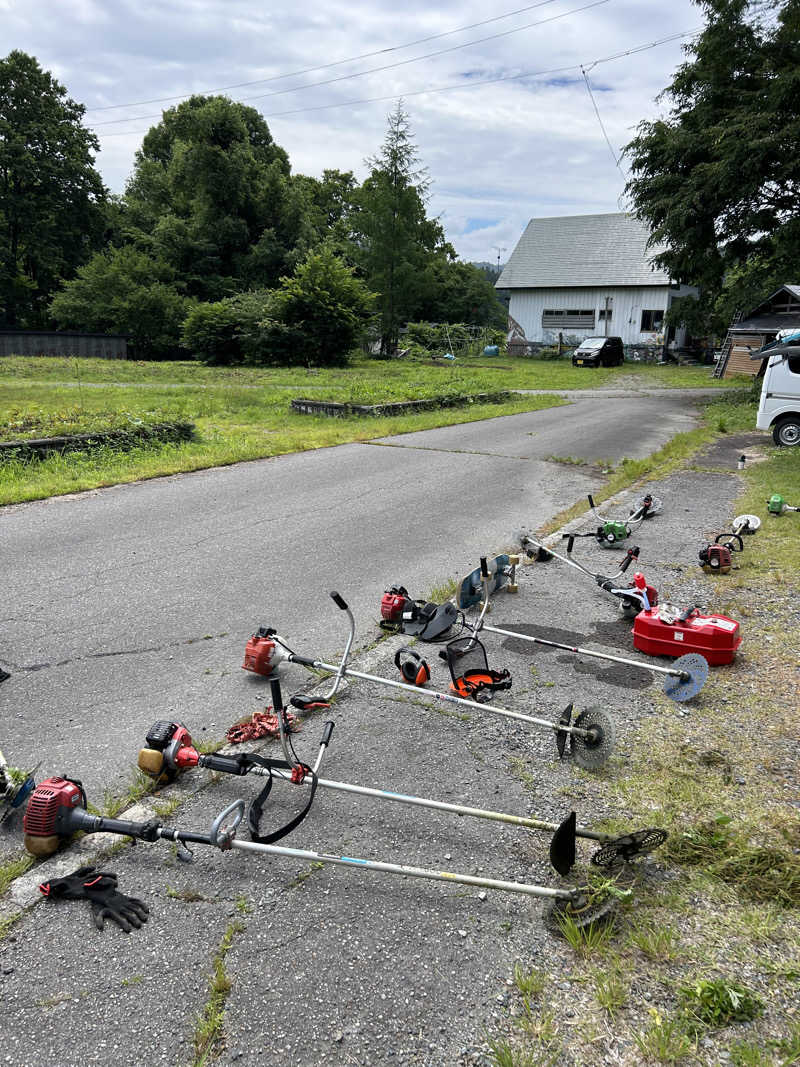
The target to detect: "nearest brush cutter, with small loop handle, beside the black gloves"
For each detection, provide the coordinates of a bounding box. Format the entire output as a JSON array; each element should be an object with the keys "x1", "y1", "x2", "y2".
[{"x1": 25, "y1": 778, "x2": 642, "y2": 926}]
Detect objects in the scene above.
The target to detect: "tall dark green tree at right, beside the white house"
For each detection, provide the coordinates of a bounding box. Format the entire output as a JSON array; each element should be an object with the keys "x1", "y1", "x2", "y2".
[{"x1": 626, "y1": 0, "x2": 800, "y2": 329}]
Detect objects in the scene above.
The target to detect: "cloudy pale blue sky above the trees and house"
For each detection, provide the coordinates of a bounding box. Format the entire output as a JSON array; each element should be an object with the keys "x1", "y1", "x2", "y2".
[{"x1": 0, "y1": 0, "x2": 702, "y2": 261}]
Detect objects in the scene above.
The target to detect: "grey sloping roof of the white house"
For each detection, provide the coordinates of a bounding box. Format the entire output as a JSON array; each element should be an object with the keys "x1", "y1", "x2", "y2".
[{"x1": 496, "y1": 211, "x2": 670, "y2": 289}]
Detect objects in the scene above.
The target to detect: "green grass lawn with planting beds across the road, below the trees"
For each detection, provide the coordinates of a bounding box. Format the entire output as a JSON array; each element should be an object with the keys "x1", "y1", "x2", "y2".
[{"x1": 0, "y1": 356, "x2": 750, "y2": 505}]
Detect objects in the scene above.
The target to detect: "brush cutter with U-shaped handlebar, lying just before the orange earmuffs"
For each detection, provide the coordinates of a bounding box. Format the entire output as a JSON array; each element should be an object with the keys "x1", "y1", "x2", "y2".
[{"x1": 242, "y1": 592, "x2": 614, "y2": 769}]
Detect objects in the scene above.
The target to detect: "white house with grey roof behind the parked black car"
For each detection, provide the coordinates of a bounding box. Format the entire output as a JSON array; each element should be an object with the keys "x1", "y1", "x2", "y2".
[{"x1": 495, "y1": 211, "x2": 697, "y2": 351}]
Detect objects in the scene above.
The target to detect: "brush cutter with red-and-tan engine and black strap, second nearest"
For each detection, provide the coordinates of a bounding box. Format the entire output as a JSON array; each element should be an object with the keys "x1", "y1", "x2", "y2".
[{"x1": 139, "y1": 680, "x2": 667, "y2": 876}]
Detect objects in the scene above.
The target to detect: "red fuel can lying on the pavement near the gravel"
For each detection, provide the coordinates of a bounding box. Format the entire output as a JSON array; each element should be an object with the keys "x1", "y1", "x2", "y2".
[{"x1": 633, "y1": 604, "x2": 741, "y2": 667}]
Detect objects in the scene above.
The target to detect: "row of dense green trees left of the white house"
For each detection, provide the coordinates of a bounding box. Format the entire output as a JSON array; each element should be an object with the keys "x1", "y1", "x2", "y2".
[{"x1": 0, "y1": 51, "x2": 505, "y2": 364}]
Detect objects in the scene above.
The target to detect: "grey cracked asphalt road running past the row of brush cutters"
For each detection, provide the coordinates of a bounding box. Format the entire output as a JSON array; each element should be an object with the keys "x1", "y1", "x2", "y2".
[{"x1": 0, "y1": 391, "x2": 712, "y2": 798}]
